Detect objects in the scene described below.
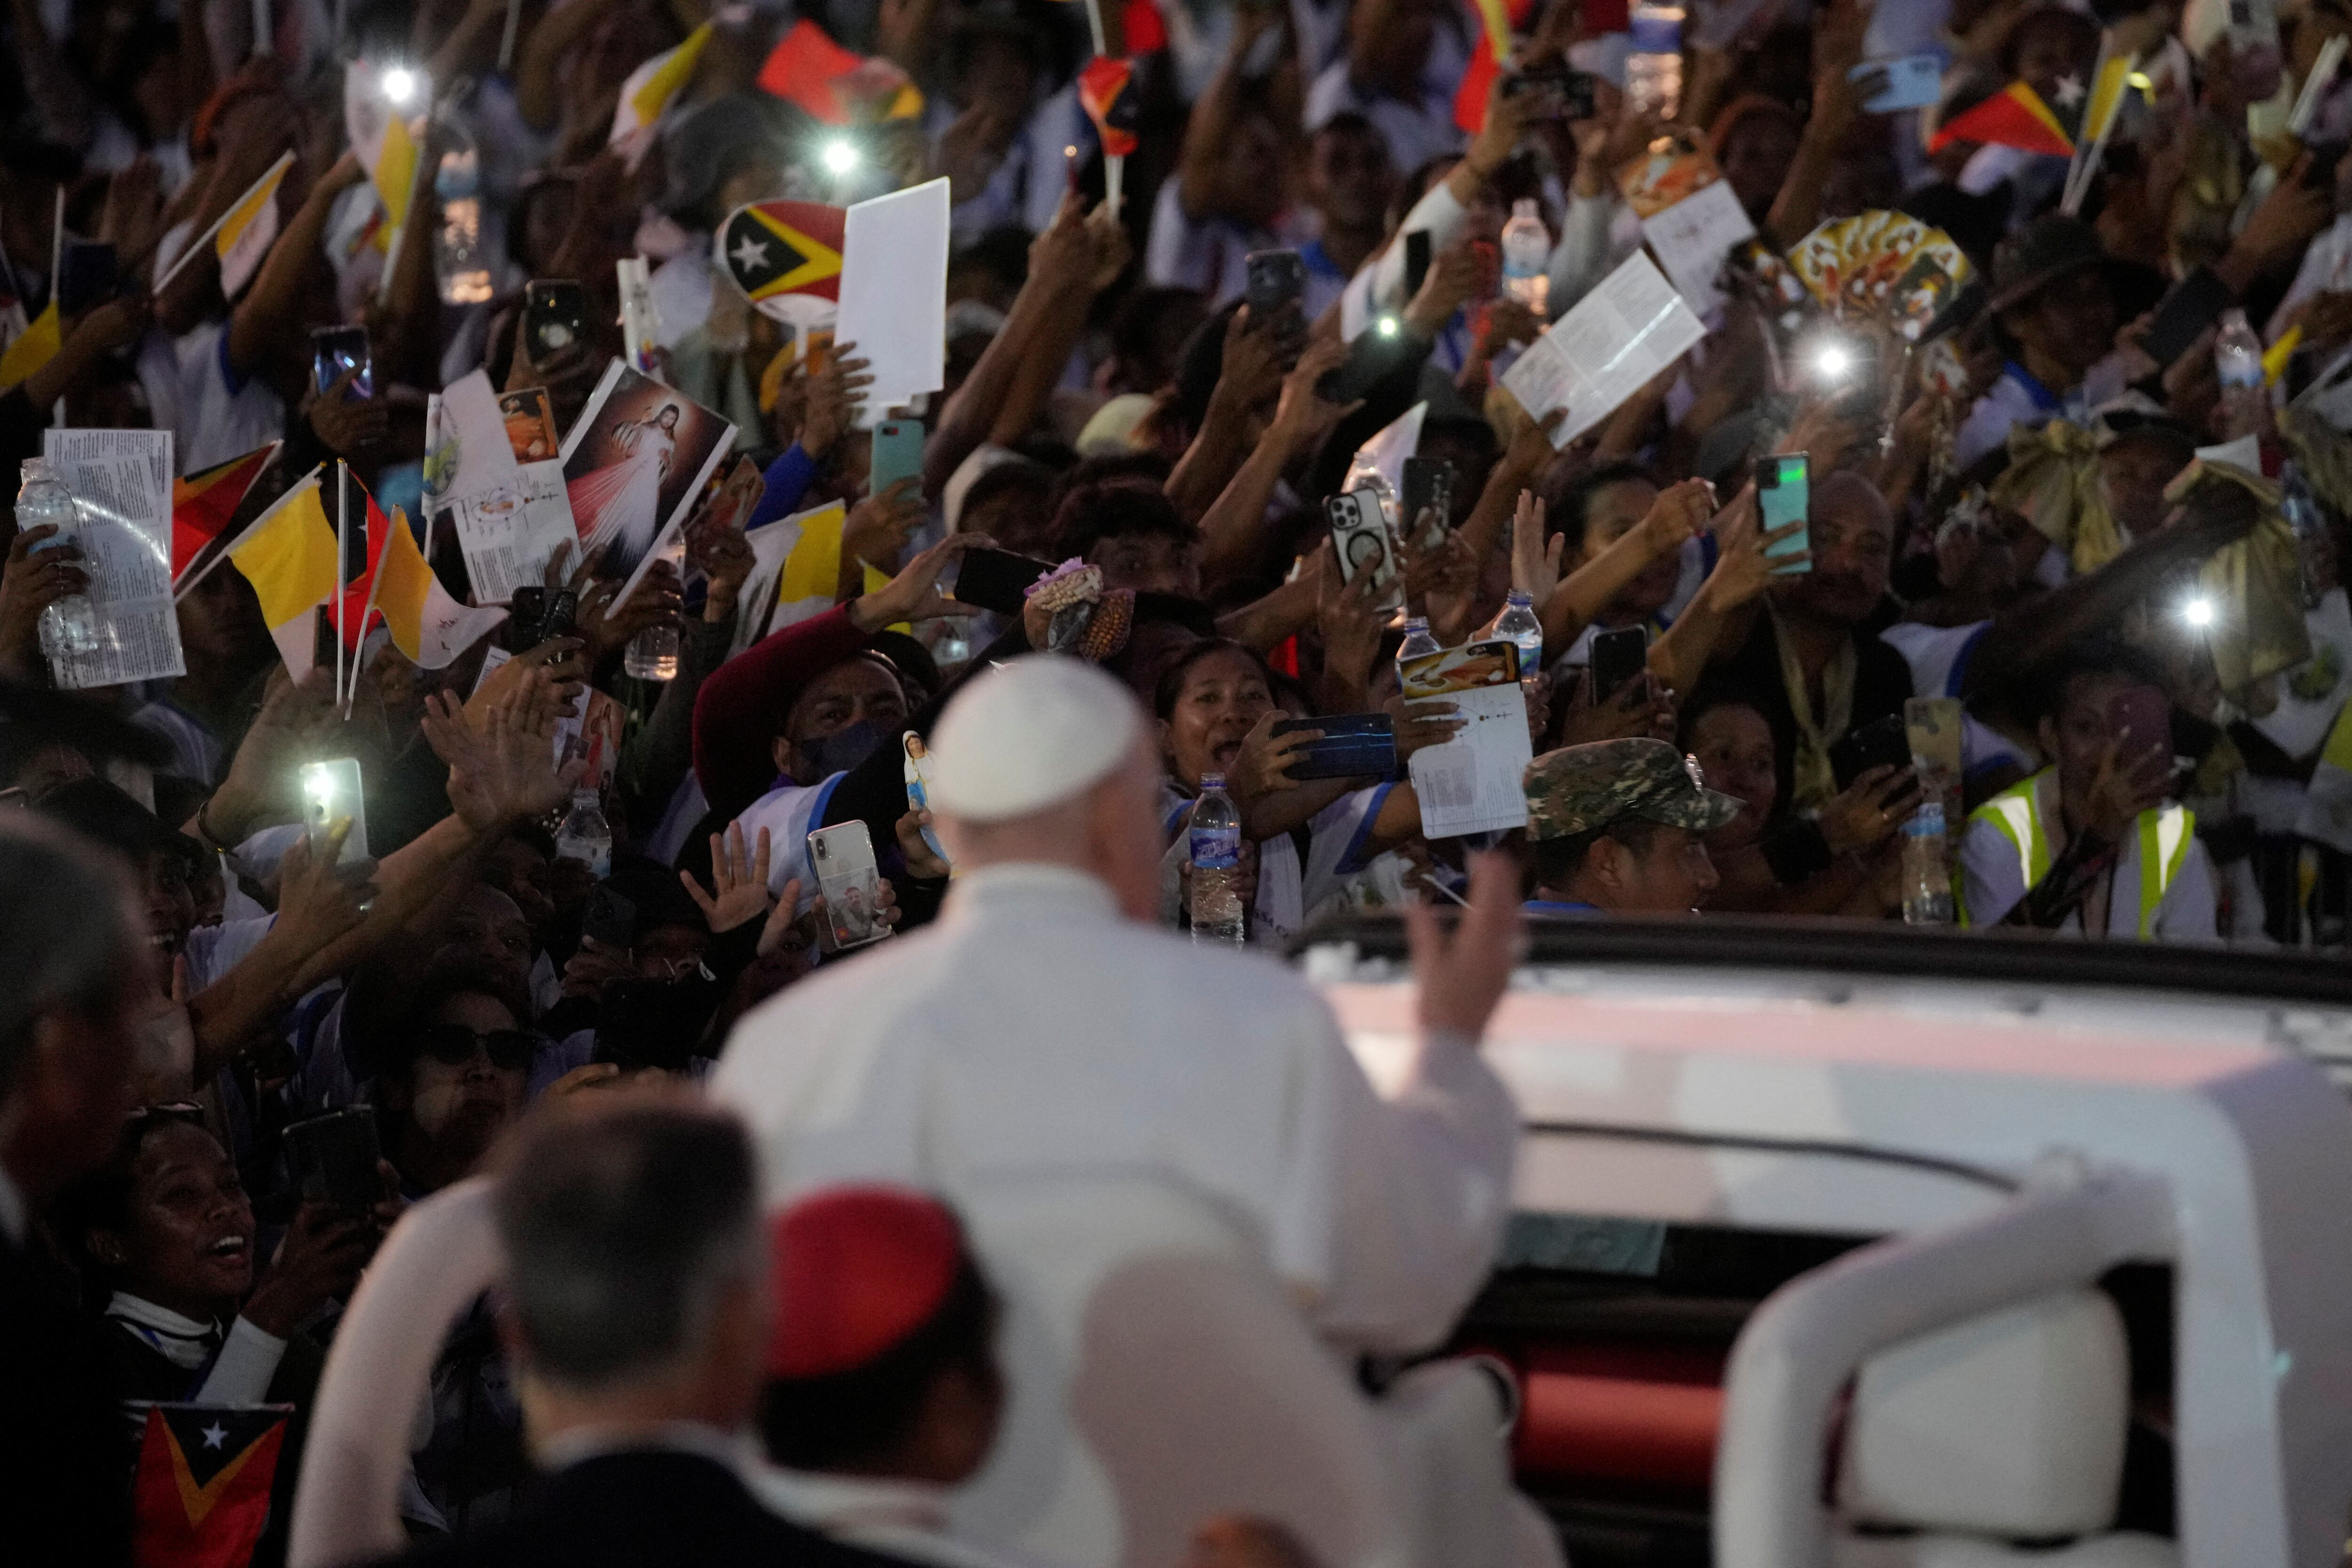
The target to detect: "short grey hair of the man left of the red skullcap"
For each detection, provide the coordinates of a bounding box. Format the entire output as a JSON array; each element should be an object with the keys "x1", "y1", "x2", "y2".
[{"x1": 496, "y1": 1100, "x2": 767, "y2": 1389}]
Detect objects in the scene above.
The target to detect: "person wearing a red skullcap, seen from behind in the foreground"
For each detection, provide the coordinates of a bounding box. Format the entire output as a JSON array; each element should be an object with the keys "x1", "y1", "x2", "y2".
[{"x1": 755, "y1": 1187, "x2": 1004, "y2": 1563}]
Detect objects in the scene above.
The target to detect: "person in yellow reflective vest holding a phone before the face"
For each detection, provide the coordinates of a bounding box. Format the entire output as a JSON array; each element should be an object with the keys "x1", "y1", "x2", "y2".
[{"x1": 1959, "y1": 646, "x2": 2218, "y2": 943}]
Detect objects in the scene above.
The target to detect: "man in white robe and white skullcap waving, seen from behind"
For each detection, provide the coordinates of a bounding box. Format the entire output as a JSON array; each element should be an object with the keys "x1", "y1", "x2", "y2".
[{"x1": 713, "y1": 656, "x2": 1519, "y2": 1568}]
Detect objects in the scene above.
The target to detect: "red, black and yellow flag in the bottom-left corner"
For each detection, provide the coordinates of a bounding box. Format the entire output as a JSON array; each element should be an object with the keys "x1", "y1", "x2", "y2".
[{"x1": 132, "y1": 1403, "x2": 294, "y2": 1568}]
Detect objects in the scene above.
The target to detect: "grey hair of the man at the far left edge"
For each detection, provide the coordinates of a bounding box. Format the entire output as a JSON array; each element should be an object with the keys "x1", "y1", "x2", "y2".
[{"x1": 0, "y1": 811, "x2": 141, "y2": 1098}]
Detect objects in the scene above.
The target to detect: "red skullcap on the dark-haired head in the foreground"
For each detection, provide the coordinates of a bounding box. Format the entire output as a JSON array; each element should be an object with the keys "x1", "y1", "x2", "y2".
[{"x1": 767, "y1": 1187, "x2": 964, "y2": 1377}]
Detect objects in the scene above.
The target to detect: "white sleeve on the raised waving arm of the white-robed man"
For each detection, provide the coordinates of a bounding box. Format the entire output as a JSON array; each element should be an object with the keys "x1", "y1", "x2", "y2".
[{"x1": 1272, "y1": 1002, "x2": 1519, "y2": 1352}]
